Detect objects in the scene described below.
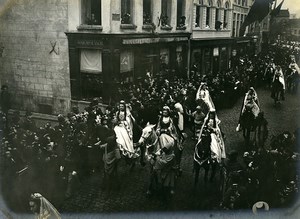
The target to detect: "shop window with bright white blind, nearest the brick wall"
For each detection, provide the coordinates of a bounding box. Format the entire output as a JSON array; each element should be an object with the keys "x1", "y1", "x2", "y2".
[{"x1": 80, "y1": 49, "x2": 103, "y2": 99}]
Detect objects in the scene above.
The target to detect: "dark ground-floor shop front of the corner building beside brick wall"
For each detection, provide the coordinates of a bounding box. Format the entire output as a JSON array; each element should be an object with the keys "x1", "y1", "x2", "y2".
[{"x1": 67, "y1": 32, "x2": 189, "y2": 103}]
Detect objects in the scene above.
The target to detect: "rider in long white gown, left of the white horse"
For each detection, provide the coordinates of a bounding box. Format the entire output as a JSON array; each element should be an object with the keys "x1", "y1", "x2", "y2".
[{"x1": 114, "y1": 101, "x2": 138, "y2": 158}]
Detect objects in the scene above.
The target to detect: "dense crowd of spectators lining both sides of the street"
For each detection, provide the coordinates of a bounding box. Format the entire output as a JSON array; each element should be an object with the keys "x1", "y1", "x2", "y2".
[{"x1": 1, "y1": 41, "x2": 296, "y2": 212}]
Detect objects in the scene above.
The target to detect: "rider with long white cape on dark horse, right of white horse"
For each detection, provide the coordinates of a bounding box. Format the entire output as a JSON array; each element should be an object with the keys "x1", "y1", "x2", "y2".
[{"x1": 195, "y1": 111, "x2": 226, "y2": 163}]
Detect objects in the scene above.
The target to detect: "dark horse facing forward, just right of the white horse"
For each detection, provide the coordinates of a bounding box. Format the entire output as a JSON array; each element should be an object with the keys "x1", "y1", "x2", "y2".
[{"x1": 194, "y1": 133, "x2": 218, "y2": 185}]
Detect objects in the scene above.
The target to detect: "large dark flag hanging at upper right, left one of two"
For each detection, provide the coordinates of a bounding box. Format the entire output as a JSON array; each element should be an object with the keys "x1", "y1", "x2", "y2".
[{"x1": 240, "y1": 0, "x2": 274, "y2": 36}]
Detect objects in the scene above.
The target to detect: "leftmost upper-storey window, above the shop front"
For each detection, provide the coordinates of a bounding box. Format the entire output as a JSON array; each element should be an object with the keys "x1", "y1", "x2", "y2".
[{"x1": 81, "y1": 0, "x2": 101, "y2": 25}]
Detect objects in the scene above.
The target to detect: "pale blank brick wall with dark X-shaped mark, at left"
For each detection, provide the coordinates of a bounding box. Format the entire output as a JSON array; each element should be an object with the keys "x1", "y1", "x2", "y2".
[{"x1": 0, "y1": 0, "x2": 71, "y2": 113}]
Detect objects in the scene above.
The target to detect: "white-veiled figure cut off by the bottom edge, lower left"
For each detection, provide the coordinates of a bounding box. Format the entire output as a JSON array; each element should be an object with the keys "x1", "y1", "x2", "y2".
[{"x1": 29, "y1": 193, "x2": 61, "y2": 219}]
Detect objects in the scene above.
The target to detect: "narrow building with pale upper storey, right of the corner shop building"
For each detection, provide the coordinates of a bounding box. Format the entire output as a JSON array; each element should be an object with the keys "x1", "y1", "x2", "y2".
[{"x1": 190, "y1": 0, "x2": 232, "y2": 74}]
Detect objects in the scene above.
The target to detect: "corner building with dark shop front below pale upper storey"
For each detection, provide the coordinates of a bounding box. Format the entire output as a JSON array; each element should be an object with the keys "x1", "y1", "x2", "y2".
[{"x1": 66, "y1": 0, "x2": 192, "y2": 102}]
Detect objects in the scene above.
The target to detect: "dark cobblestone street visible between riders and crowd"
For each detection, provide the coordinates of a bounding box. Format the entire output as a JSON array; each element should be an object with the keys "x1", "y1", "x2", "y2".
[{"x1": 59, "y1": 89, "x2": 300, "y2": 213}]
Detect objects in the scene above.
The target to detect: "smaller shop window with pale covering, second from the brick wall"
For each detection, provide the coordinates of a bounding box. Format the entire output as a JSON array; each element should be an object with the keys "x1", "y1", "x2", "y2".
[{"x1": 120, "y1": 50, "x2": 134, "y2": 82}]
